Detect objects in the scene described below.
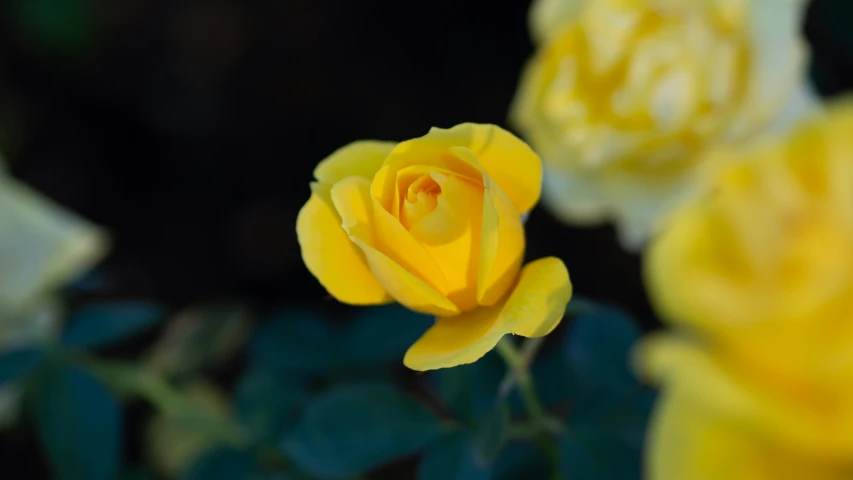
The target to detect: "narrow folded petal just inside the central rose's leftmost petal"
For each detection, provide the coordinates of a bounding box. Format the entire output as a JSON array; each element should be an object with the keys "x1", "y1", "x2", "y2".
[{"x1": 332, "y1": 177, "x2": 459, "y2": 315}]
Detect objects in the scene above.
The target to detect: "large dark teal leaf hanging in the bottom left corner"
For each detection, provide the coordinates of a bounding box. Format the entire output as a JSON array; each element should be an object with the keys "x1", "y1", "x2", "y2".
[{"x1": 33, "y1": 366, "x2": 122, "y2": 480}]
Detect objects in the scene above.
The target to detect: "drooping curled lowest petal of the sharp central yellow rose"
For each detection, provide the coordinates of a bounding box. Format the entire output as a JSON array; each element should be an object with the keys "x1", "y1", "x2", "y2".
[{"x1": 403, "y1": 258, "x2": 572, "y2": 371}]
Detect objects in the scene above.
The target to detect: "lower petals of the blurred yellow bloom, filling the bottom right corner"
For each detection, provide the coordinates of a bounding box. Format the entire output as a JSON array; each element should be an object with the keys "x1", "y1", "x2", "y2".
[{"x1": 639, "y1": 338, "x2": 853, "y2": 480}]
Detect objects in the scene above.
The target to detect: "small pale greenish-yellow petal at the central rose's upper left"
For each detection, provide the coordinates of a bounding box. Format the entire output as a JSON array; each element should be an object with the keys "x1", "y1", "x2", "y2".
[{"x1": 314, "y1": 140, "x2": 396, "y2": 185}]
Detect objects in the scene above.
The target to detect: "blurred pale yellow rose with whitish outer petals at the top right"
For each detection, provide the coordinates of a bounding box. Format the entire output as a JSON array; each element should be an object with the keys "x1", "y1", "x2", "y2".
[{"x1": 511, "y1": 0, "x2": 814, "y2": 248}]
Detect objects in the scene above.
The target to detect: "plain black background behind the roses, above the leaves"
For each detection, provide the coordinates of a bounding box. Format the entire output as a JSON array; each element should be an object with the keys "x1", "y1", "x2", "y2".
[{"x1": 0, "y1": 0, "x2": 853, "y2": 478}]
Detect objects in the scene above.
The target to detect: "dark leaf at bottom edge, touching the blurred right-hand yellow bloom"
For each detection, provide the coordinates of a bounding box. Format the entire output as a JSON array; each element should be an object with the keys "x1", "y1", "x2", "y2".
[{"x1": 559, "y1": 428, "x2": 642, "y2": 480}]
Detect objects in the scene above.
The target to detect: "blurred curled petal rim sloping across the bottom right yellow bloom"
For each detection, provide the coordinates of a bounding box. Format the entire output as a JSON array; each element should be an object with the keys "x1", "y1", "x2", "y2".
[{"x1": 633, "y1": 335, "x2": 853, "y2": 462}]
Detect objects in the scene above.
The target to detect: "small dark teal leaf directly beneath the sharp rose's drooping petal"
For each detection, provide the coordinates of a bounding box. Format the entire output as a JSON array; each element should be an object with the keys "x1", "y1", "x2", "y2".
[{"x1": 432, "y1": 352, "x2": 506, "y2": 425}]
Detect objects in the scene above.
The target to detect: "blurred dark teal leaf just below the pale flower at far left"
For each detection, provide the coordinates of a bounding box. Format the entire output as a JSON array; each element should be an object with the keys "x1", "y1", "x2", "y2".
[{"x1": 62, "y1": 301, "x2": 166, "y2": 348}]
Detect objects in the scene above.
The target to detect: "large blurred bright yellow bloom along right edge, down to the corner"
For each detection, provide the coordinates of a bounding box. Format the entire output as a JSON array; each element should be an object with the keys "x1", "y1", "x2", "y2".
[{"x1": 638, "y1": 104, "x2": 853, "y2": 480}]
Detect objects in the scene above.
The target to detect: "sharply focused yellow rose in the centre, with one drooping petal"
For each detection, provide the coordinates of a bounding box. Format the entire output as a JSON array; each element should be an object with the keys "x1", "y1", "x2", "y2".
[{"x1": 296, "y1": 124, "x2": 572, "y2": 370}]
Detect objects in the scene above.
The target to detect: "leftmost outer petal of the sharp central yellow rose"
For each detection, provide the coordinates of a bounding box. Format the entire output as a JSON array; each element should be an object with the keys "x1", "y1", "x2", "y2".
[{"x1": 296, "y1": 191, "x2": 391, "y2": 305}]
